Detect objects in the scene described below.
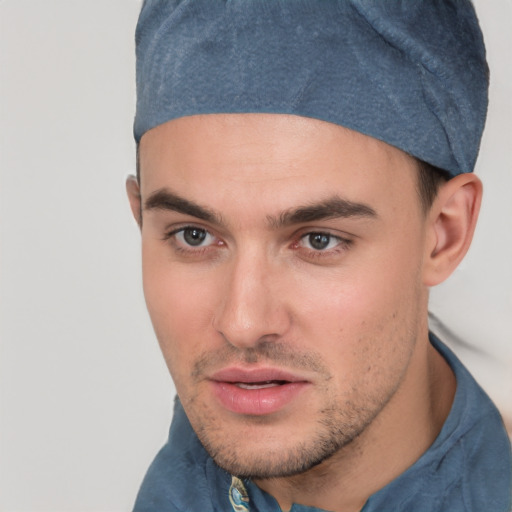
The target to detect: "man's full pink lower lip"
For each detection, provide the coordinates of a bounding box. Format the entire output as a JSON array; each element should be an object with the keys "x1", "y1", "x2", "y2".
[{"x1": 212, "y1": 381, "x2": 309, "y2": 416}]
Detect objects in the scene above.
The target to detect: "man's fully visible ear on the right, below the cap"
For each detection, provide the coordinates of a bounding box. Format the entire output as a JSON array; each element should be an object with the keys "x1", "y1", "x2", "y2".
[{"x1": 423, "y1": 173, "x2": 482, "y2": 286}]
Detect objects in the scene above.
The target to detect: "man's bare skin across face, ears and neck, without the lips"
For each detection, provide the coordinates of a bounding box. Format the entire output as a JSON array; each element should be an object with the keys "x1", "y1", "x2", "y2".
[{"x1": 127, "y1": 114, "x2": 481, "y2": 512}]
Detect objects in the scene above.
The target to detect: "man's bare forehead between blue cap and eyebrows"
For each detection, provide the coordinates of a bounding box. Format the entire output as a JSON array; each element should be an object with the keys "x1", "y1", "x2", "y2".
[{"x1": 139, "y1": 114, "x2": 418, "y2": 219}]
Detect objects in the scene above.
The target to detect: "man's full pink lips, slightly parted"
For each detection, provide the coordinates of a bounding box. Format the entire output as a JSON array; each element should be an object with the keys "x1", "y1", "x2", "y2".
[{"x1": 210, "y1": 368, "x2": 310, "y2": 416}]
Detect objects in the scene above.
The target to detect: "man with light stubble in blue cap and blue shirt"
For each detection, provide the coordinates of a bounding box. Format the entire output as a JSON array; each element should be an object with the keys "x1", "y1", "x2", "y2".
[{"x1": 127, "y1": 0, "x2": 511, "y2": 512}]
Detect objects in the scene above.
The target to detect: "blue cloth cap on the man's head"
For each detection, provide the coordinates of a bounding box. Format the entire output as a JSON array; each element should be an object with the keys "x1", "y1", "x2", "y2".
[{"x1": 134, "y1": 0, "x2": 488, "y2": 175}]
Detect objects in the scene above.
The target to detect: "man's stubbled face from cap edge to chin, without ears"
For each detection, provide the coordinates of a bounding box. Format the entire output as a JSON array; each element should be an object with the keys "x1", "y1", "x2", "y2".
[{"x1": 136, "y1": 114, "x2": 427, "y2": 478}]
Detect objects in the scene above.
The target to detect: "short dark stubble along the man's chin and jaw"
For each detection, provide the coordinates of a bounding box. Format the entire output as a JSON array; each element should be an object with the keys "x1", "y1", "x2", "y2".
[{"x1": 183, "y1": 340, "x2": 408, "y2": 479}]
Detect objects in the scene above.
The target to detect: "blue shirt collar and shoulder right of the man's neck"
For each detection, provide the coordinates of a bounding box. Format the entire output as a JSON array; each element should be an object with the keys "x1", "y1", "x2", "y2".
[{"x1": 363, "y1": 337, "x2": 512, "y2": 512}]
